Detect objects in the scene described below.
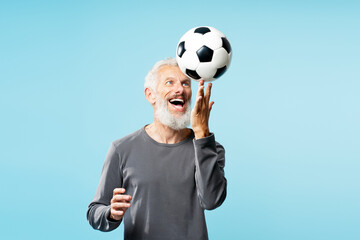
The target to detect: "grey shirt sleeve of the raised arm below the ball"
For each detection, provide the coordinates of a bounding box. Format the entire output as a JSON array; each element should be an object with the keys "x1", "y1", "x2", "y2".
[{"x1": 193, "y1": 133, "x2": 227, "y2": 210}]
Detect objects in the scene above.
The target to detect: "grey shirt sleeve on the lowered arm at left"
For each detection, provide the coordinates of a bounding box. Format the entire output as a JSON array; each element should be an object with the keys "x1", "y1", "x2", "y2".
[{"x1": 87, "y1": 144, "x2": 122, "y2": 232}]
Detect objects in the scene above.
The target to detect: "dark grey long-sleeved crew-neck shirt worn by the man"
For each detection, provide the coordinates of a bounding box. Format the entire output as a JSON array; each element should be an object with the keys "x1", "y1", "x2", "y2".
[{"x1": 87, "y1": 128, "x2": 227, "y2": 240}]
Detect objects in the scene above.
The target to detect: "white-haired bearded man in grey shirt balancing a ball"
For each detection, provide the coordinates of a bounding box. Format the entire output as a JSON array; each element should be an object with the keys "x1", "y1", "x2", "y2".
[{"x1": 87, "y1": 58, "x2": 227, "y2": 240}]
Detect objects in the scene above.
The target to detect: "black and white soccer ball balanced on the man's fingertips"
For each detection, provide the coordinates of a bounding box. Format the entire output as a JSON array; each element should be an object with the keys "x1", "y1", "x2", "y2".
[{"x1": 176, "y1": 26, "x2": 232, "y2": 82}]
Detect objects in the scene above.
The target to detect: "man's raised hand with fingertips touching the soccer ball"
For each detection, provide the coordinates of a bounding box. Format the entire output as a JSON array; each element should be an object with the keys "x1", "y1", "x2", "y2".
[{"x1": 191, "y1": 80, "x2": 214, "y2": 139}]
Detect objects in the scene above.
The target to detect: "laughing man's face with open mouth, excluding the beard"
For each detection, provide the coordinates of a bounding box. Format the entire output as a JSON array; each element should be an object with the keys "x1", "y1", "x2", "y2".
[{"x1": 156, "y1": 65, "x2": 191, "y2": 117}]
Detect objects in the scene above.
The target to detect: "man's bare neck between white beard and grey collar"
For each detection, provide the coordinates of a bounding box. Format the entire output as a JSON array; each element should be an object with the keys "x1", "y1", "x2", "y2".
[{"x1": 145, "y1": 119, "x2": 191, "y2": 144}]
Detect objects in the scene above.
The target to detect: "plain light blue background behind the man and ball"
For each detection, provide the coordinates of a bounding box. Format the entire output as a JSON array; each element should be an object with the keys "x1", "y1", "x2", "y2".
[{"x1": 0, "y1": 0, "x2": 360, "y2": 240}]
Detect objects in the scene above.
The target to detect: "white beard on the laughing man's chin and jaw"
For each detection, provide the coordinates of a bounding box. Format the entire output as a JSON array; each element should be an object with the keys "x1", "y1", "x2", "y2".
[{"x1": 155, "y1": 96, "x2": 191, "y2": 130}]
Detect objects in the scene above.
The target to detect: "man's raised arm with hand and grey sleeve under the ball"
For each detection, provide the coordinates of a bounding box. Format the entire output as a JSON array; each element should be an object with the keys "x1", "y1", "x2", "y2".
[{"x1": 191, "y1": 81, "x2": 227, "y2": 210}]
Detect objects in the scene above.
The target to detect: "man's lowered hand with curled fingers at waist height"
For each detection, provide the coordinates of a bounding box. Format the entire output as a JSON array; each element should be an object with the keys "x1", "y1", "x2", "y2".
[{"x1": 110, "y1": 188, "x2": 132, "y2": 221}]
